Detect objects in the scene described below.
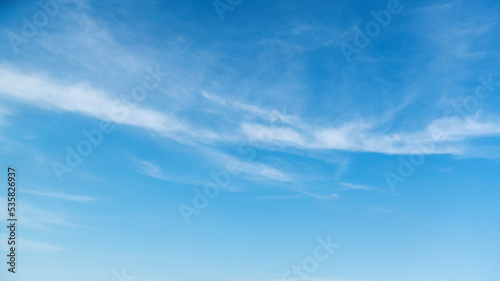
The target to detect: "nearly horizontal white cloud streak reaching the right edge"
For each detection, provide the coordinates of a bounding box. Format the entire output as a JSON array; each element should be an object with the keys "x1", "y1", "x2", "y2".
[{"x1": 241, "y1": 117, "x2": 500, "y2": 155}]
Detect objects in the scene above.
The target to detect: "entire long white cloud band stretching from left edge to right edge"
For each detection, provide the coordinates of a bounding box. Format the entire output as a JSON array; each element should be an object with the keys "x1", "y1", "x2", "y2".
[{"x1": 0, "y1": 62, "x2": 500, "y2": 159}]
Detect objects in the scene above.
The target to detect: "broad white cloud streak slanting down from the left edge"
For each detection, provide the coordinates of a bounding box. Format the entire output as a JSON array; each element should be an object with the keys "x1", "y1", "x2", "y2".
[{"x1": 0, "y1": 65, "x2": 217, "y2": 140}]
